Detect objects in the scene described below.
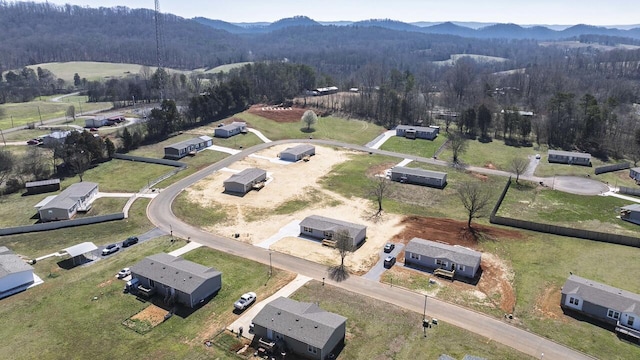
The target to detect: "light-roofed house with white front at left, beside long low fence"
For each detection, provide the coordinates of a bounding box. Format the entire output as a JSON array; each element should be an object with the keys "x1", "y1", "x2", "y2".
[{"x1": 35, "y1": 181, "x2": 98, "y2": 222}]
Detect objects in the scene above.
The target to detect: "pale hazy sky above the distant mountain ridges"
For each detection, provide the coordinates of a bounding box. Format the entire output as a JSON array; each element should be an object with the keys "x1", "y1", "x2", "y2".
[{"x1": 37, "y1": 0, "x2": 640, "y2": 25}]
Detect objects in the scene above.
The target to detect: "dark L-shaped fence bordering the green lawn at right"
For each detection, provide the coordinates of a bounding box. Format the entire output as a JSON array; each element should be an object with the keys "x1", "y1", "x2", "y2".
[{"x1": 489, "y1": 178, "x2": 640, "y2": 247}]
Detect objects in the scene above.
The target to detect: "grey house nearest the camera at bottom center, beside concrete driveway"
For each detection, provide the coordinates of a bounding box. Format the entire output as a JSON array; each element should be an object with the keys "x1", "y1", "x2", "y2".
[{"x1": 253, "y1": 297, "x2": 347, "y2": 360}]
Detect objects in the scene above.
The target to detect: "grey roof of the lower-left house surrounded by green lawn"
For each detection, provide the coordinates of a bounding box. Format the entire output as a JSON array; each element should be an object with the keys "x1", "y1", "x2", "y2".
[{"x1": 131, "y1": 253, "x2": 222, "y2": 294}]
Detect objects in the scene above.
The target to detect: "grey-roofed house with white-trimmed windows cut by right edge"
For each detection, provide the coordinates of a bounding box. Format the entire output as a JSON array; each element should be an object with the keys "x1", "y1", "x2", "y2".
[{"x1": 560, "y1": 274, "x2": 640, "y2": 339}]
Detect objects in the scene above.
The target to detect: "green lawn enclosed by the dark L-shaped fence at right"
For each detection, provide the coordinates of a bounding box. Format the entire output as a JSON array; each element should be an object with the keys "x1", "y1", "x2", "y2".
[{"x1": 498, "y1": 181, "x2": 640, "y2": 236}]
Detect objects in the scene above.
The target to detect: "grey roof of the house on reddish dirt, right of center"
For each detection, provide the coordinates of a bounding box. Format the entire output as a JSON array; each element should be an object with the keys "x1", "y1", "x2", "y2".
[{"x1": 404, "y1": 238, "x2": 482, "y2": 266}]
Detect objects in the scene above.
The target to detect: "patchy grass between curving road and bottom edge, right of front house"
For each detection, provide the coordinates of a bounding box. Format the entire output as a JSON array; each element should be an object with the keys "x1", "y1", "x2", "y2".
[{"x1": 292, "y1": 281, "x2": 530, "y2": 359}]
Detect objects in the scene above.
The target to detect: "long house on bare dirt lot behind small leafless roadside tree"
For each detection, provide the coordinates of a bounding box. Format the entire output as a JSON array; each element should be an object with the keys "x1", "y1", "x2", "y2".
[{"x1": 300, "y1": 215, "x2": 367, "y2": 248}]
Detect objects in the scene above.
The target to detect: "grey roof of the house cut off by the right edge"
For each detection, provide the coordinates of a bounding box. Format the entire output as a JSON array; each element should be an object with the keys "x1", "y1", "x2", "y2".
[{"x1": 562, "y1": 275, "x2": 640, "y2": 314}]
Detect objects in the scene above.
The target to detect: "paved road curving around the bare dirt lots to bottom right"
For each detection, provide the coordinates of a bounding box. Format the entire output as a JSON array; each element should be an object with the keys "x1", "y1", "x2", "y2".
[{"x1": 147, "y1": 139, "x2": 593, "y2": 359}]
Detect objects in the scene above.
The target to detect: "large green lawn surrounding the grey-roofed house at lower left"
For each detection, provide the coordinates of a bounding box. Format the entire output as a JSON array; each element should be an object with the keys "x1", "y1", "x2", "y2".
[{"x1": 0, "y1": 237, "x2": 292, "y2": 359}]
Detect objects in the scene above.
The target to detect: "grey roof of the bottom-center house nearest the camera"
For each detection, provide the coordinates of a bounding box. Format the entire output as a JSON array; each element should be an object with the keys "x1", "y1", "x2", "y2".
[{"x1": 253, "y1": 297, "x2": 347, "y2": 349}]
